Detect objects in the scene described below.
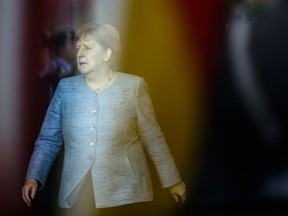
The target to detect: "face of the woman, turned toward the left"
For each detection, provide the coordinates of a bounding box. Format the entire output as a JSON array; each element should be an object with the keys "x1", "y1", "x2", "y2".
[{"x1": 76, "y1": 36, "x2": 107, "y2": 75}]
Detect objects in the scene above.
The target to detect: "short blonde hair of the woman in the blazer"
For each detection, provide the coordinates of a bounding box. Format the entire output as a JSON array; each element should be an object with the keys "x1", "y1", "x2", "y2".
[{"x1": 75, "y1": 23, "x2": 121, "y2": 69}]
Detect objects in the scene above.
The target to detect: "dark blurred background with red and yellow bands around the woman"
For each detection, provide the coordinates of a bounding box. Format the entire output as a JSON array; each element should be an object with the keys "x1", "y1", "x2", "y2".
[{"x1": 0, "y1": 0, "x2": 288, "y2": 216}]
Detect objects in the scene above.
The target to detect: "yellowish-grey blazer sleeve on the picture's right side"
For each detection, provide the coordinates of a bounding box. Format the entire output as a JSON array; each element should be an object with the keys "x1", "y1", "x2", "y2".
[{"x1": 137, "y1": 79, "x2": 181, "y2": 187}]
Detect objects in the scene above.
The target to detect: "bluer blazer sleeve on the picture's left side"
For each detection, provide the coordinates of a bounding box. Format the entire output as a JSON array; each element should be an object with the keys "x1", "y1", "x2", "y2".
[{"x1": 26, "y1": 79, "x2": 63, "y2": 190}]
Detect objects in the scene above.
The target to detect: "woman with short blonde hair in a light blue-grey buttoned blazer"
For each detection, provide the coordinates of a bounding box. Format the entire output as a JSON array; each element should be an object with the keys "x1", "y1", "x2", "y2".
[{"x1": 22, "y1": 23, "x2": 186, "y2": 215}]
